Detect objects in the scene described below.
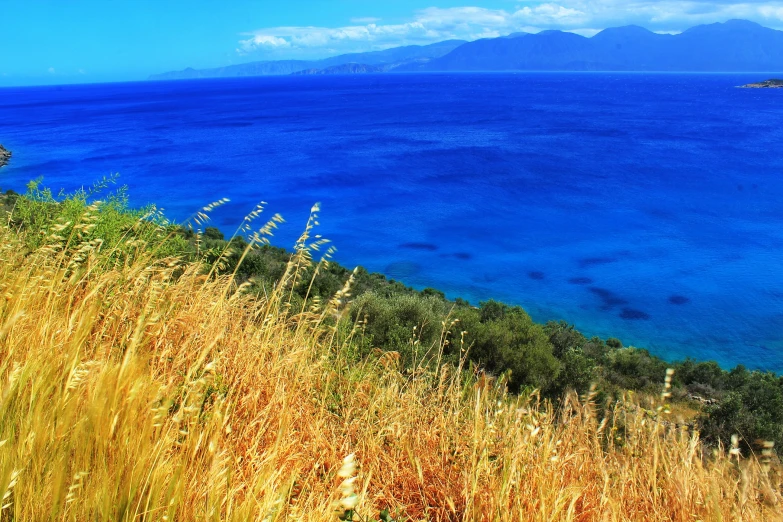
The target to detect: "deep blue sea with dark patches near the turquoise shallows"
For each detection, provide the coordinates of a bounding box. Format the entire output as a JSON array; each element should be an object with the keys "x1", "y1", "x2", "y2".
[{"x1": 0, "y1": 73, "x2": 783, "y2": 372}]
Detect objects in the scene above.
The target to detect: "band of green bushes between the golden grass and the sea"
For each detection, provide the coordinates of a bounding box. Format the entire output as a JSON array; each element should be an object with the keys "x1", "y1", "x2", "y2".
[{"x1": 0, "y1": 180, "x2": 783, "y2": 452}]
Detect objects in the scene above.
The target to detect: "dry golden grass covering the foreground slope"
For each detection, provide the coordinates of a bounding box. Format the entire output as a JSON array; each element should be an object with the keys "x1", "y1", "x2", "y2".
[{"x1": 0, "y1": 204, "x2": 783, "y2": 521}]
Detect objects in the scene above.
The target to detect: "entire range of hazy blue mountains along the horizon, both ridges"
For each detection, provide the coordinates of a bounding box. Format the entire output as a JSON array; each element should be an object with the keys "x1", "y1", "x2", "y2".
[{"x1": 150, "y1": 20, "x2": 783, "y2": 80}]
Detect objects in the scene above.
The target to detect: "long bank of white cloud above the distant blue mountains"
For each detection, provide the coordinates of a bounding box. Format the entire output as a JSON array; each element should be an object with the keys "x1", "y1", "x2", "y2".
[{"x1": 237, "y1": 0, "x2": 783, "y2": 58}]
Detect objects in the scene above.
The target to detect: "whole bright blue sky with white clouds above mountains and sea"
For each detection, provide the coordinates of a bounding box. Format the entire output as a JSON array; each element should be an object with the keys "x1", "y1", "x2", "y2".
[{"x1": 0, "y1": 0, "x2": 783, "y2": 86}]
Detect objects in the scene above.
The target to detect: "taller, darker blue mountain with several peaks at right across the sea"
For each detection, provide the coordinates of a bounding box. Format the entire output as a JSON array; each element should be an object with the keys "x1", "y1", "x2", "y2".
[{"x1": 408, "y1": 20, "x2": 783, "y2": 72}]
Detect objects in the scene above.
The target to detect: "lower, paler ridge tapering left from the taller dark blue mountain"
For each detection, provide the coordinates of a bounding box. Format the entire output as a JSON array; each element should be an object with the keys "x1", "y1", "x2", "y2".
[{"x1": 149, "y1": 40, "x2": 465, "y2": 80}]
